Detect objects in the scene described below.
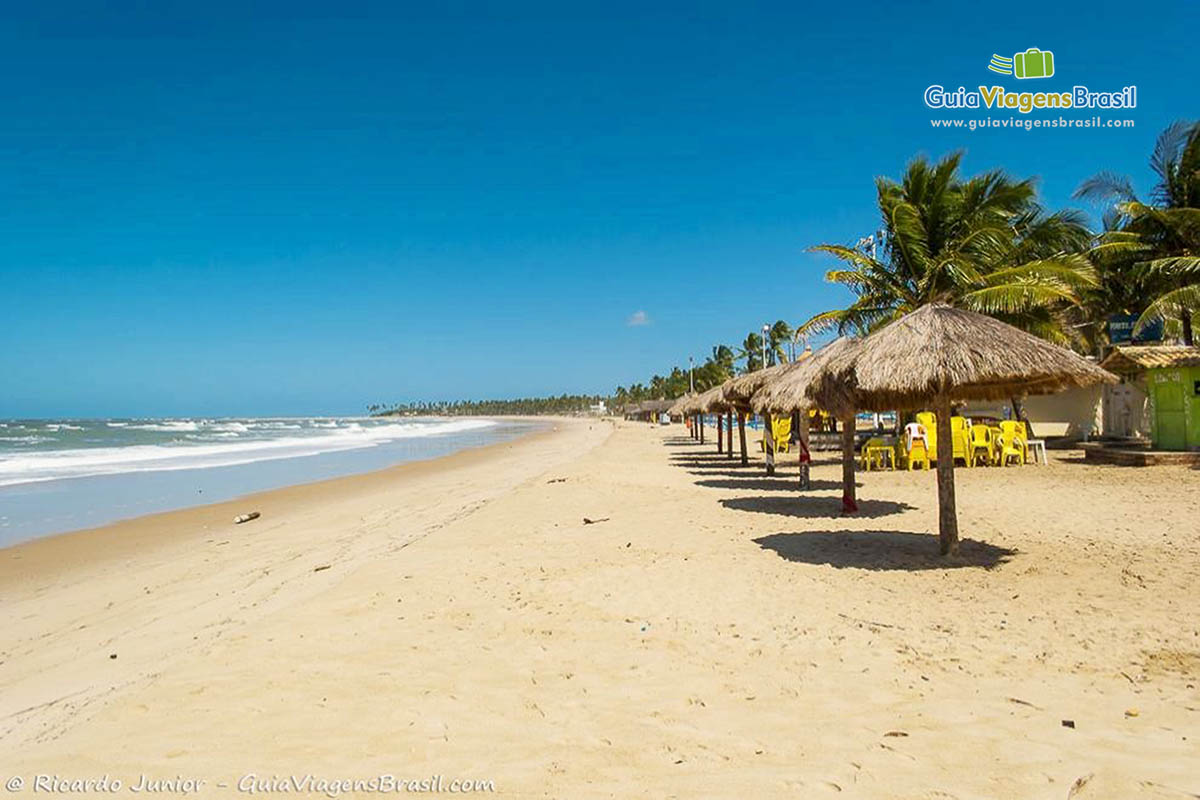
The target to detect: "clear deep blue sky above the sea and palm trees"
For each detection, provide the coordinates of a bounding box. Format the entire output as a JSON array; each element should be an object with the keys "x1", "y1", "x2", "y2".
[{"x1": 0, "y1": 0, "x2": 1200, "y2": 417}]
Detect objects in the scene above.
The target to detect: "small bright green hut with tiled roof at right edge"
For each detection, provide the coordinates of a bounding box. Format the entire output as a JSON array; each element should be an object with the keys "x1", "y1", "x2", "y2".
[{"x1": 1100, "y1": 344, "x2": 1200, "y2": 450}]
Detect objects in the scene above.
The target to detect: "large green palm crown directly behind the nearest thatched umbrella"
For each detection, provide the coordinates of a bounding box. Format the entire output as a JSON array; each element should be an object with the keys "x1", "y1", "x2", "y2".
[{"x1": 797, "y1": 154, "x2": 1096, "y2": 342}]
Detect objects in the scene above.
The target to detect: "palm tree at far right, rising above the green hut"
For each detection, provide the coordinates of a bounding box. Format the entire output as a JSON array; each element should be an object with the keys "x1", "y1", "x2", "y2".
[{"x1": 1075, "y1": 120, "x2": 1200, "y2": 345}]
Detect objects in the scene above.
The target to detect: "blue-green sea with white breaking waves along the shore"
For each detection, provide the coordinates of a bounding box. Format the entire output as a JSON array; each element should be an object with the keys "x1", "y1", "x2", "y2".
[{"x1": 0, "y1": 417, "x2": 545, "y2": 547}]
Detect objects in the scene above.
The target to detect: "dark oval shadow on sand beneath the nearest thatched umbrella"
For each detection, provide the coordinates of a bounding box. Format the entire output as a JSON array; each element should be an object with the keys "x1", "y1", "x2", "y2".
[{"x1": 754, "y1": 530, "x2": 1018, "y2": 571}]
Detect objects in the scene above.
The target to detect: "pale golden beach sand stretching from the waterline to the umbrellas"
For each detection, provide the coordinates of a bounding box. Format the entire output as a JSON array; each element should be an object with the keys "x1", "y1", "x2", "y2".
[{"x1": 0, "y1": 422, "x2": 1200, "y2": 800}]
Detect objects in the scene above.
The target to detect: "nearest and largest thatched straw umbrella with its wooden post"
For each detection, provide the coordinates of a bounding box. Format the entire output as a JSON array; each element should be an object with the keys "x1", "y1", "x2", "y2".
[{"x1": 815, "y1": 303, "x2": 1116, "y2": 554}]
